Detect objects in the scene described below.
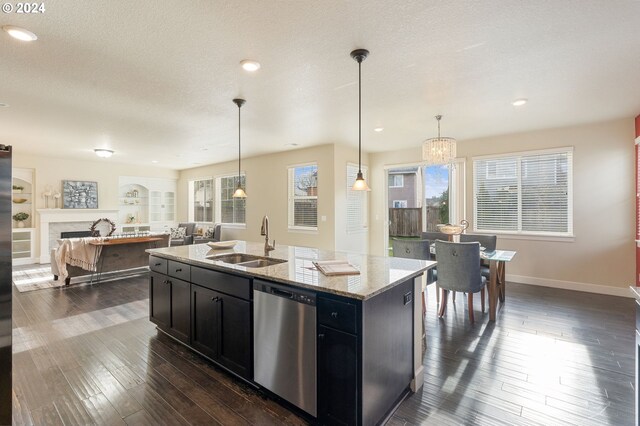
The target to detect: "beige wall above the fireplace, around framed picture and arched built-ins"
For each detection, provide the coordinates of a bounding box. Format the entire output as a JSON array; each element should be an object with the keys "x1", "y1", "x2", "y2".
[{"x1": 13, "y1": 151, "x2": 178, "y2": 253}]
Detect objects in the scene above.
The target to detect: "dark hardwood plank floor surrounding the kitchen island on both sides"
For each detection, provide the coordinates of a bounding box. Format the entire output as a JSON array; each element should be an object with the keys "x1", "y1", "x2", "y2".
[{"x1": 13, "y1": 277, "x2": 635, "y2": 426}]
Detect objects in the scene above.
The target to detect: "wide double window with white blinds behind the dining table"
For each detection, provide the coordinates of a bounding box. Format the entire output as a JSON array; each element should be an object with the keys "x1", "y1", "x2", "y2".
[{"x1": 473, "y1": 148, "x2": 573, "y2": 236}]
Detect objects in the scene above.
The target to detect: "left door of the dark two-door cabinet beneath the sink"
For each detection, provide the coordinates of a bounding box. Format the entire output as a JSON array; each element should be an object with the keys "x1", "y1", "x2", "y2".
[{"x1": 191, "y1": 285, "x2": 221, "y2": 359}]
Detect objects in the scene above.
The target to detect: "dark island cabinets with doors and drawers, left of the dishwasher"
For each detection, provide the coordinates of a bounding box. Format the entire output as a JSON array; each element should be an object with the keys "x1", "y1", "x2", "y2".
[{"x1": 149, "y1": 256, "x2": 253, "y2": 380}]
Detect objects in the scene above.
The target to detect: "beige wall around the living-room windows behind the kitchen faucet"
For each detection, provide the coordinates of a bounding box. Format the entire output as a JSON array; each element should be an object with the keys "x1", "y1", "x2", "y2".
[{"x1": 178, "y1": 145, "x2": 335, "y2": 250}]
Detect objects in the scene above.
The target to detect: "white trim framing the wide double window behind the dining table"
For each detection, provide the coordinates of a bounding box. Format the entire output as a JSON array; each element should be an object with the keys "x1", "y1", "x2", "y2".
[{"x1": 471, "y1": 146, "x2": 575, "y2": 238}]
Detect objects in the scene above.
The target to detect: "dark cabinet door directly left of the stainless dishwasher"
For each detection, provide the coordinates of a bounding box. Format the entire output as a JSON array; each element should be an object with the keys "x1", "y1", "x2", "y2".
[{"x1": 218, "y1": 295, "x2": 252, "y2": 379}]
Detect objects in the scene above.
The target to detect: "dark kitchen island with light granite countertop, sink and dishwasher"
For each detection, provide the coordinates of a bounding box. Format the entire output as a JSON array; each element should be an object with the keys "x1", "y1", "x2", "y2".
[{"x1": 147, "y1": 241, "x2": 435, "y2": 425}]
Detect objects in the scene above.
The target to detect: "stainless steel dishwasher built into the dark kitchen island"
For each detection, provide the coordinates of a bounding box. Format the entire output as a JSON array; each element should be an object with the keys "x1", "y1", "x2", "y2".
[{"x1": 253, "y1": 280, "x2": 317, "y2": 417}]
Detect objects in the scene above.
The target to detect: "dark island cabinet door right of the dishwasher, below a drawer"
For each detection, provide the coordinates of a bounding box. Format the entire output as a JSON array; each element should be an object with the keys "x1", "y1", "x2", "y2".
[{"x1": 318, "y1": 325, "x2": 358, "y2": 425}]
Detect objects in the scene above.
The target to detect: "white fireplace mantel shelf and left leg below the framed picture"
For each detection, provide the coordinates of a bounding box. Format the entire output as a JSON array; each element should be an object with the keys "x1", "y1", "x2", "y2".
[{"x1": 37, "y1": 209, "x2": 118, "y2": 263}]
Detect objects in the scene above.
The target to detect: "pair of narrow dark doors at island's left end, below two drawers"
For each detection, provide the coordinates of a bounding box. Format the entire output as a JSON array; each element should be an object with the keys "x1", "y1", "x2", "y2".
[{"x1": 149, "y1": 272, "x2": 191, "y2": 343}]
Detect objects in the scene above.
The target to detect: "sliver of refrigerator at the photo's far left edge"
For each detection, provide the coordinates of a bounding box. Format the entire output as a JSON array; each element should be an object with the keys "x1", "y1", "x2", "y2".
[{"x1": 0, "y1": 145, "x2": 12, "y2": 425}]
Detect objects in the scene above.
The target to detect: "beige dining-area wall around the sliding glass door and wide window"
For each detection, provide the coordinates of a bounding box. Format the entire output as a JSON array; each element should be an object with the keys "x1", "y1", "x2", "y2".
[{"x1": 370, "y1": 118, "x2": 635, "y2": 295}]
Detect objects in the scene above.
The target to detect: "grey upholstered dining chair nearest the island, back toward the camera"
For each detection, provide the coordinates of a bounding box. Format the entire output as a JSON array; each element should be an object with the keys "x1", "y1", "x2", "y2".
[{"x1": 435, "y1": 240, "x2": 487, "y2": 324}]
